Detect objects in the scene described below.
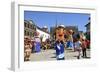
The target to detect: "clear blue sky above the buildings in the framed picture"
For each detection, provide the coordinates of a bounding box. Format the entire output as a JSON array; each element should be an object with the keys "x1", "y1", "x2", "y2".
[{"x1": 24, "y1": 11, "x2": 90, "y2": 32}]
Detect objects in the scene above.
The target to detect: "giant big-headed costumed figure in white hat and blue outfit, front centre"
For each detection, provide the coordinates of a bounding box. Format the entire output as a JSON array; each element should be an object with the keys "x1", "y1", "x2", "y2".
[{"x1": 55, "y1": 25, "x2": 65, "y2": 60}]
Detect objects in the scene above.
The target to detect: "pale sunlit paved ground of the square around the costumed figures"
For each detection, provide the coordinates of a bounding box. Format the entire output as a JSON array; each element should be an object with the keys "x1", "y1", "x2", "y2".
[{"x1": 31, "y1": 49, "x2": 90, "y2": 61}]
